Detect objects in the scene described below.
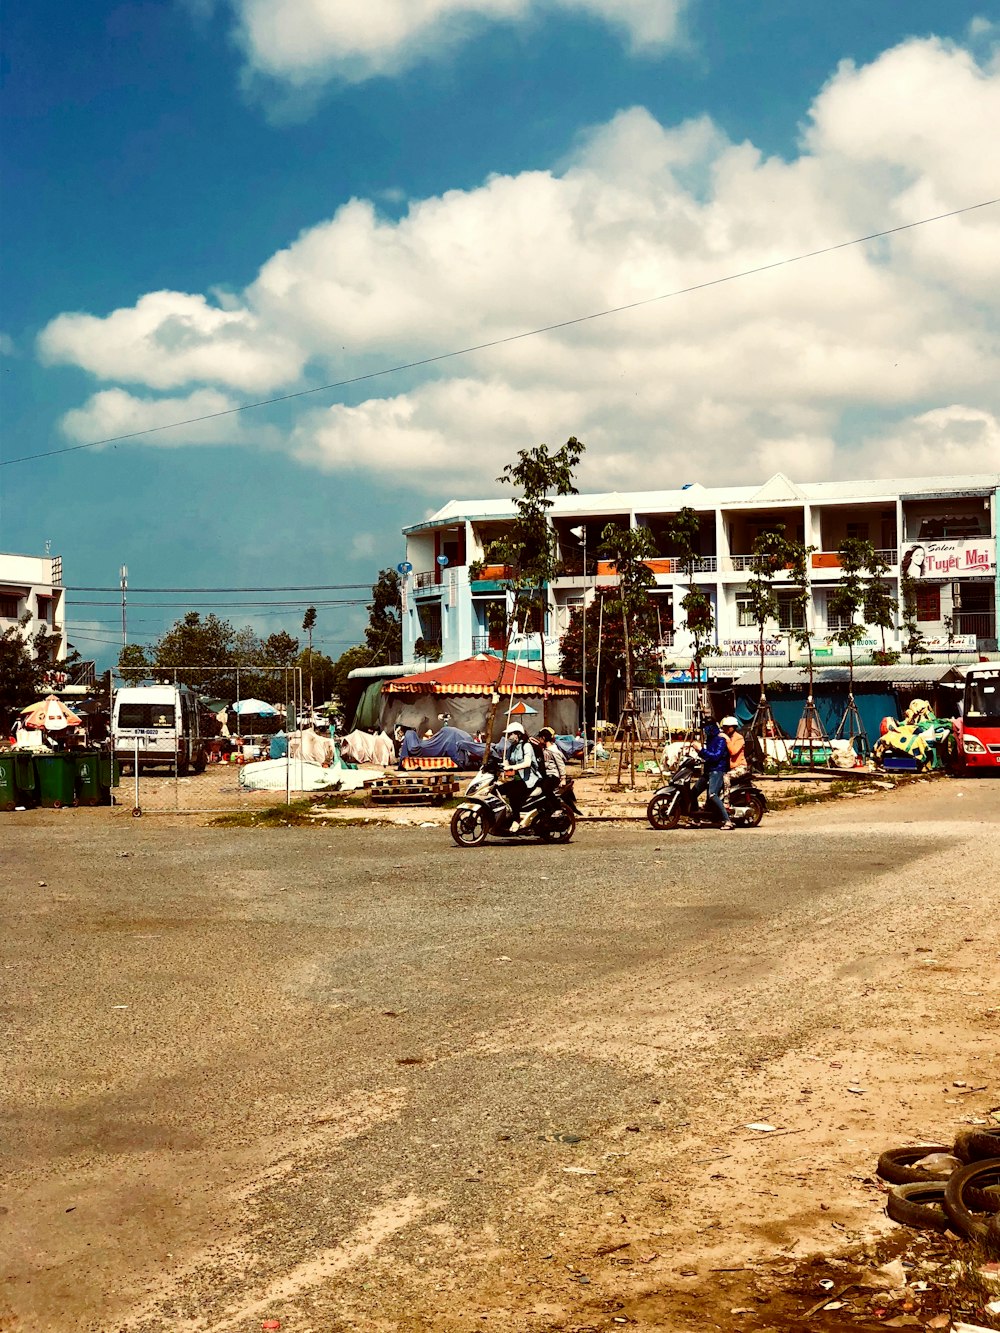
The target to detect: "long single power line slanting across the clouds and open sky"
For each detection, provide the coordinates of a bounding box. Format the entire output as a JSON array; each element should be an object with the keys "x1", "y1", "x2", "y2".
[{"x1": 0, "y1": 197, "x2": 1000, "y2": 468}]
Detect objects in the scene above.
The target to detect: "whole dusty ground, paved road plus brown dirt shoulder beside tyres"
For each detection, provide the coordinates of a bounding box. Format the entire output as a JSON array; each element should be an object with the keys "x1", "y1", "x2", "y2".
[{"x1": 0, "y1": 781, "x2": 1000, "y2": 1333}]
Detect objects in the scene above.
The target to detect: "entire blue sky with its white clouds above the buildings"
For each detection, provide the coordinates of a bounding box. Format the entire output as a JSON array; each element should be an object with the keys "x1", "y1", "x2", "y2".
[{"x1": 0, "y1": 0, "x2": 1000, "y2": 665}]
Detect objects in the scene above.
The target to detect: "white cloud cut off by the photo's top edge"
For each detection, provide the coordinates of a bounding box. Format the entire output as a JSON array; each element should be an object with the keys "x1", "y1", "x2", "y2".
[{"x1": 231, "y1": 0, "x2": 687, "y2": 87}]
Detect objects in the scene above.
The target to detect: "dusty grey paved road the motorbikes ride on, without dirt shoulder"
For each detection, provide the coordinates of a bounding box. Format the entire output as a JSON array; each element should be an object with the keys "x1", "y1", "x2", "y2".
[{"x1": 0, "y1": 782, "x2": 1000, "y2": 1333}]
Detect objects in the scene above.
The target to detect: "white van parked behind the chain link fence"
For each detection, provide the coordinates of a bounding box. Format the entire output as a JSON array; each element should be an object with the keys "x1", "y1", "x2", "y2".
[{"x1": 111, "y1": 685, "x2": 205, "y2": 773}]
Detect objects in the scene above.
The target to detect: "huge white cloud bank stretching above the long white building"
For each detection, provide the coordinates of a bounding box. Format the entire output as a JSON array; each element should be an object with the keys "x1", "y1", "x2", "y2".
[{"x1": 40, "y1": 40, "x2": 1000, "y2": 495}]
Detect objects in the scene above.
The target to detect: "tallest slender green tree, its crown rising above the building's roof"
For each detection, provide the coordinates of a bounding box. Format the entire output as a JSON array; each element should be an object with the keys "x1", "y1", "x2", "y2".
[{"x1": 487, "y1": 435, "x2": 584, "y2": 736}]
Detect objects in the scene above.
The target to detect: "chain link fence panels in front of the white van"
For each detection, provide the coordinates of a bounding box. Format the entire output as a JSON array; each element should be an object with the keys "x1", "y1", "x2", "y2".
[{"x1": 109, "y1": 664, "x2": 308, "y2": 814}]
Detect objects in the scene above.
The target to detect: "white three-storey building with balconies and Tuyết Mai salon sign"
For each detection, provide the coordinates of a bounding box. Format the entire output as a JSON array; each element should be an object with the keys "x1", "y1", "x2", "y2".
[{"x1": 403, "y1": 472, "x2": 1000, "y2": 665}]
